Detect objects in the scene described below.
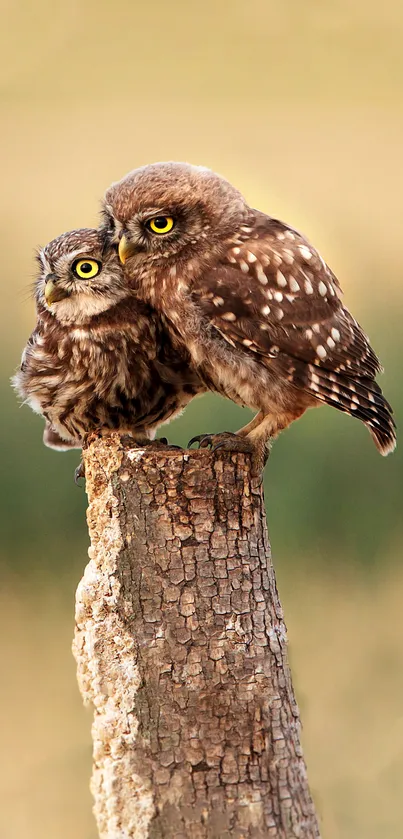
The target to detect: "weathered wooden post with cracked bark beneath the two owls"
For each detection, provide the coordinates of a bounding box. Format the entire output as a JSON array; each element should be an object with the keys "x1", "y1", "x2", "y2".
[{"x1": 74, "y1": 435, "x2": 319, "y2": 839}]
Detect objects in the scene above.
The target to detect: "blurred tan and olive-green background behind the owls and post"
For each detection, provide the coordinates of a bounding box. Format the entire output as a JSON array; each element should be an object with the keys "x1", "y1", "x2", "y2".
[{"x1": 0, "y1": 0, "x2": 403, "y2": 839}]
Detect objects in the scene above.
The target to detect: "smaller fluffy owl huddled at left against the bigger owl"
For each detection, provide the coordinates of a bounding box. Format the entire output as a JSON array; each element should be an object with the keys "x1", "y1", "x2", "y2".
[{"x1": 13, "y1": 229, "x2": 205, "y2": 450}]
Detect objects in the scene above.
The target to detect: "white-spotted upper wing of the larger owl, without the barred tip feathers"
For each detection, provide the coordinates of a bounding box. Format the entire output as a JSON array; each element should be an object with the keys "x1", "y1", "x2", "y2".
[{"x1": 192, "y1": 217, "x2": 380, "y2": 376}]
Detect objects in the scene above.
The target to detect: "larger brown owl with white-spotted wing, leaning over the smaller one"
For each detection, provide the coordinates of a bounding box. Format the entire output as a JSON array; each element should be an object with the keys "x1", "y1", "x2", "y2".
[{"x1": 103, "y1": 163, "x2": 396, "y2": 470}]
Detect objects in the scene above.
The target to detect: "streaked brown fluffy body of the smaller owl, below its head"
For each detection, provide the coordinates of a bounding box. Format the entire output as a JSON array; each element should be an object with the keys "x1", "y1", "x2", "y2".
[{"x1": 14, "y1": 301, "x2": 203, "y2": 450}]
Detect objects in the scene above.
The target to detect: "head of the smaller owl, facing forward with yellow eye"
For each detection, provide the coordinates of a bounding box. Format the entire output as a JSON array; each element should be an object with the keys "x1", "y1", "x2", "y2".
[{"x1": 35, "y1": 229, "x2": 128, "y2": 324}]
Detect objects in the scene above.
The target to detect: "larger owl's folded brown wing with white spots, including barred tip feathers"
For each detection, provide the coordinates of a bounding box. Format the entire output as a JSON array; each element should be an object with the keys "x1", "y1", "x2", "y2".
[{"x1": 192, "y1": 214, "x2": 393, "y2": 452}]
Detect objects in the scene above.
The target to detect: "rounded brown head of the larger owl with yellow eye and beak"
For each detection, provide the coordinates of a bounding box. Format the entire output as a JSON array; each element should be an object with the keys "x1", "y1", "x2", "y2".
[{"x1": 103, "y1": 163, "x2": 248, "y2": 266}]
